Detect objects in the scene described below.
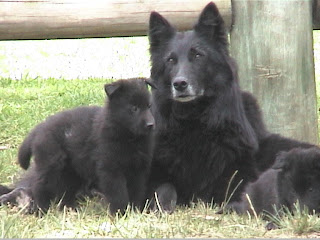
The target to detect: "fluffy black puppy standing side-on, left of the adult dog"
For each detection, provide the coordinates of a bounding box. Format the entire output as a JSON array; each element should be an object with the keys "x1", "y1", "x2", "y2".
[{"x1": 5, "y1": 79, "x2": 154, "y2": 213}]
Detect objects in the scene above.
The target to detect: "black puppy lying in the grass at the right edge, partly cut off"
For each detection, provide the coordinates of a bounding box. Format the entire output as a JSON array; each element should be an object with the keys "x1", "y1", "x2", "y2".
[{"x1": 231, "y1": 147, "x2": 320, "y2": 214}]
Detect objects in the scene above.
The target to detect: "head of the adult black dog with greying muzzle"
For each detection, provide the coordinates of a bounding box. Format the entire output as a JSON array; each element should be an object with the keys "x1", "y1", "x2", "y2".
[{"x1": 149, "y1": 3, "x2": 232, "y2": 102}]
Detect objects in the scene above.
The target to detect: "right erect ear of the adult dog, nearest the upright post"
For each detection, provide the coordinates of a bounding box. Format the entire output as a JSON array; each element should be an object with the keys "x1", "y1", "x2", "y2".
[{"x1": 194, "y1": 2, "x2": 226, "y2": 41}]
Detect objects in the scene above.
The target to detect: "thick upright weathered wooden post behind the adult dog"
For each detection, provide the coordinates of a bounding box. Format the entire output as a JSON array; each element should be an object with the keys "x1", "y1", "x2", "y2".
[{"x1": 231, "y1": 0, "x2": 318, "y2": 143}]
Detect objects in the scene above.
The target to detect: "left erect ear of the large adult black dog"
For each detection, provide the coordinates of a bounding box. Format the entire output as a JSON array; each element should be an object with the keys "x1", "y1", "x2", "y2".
[{"x1": 149, "y1": 12, "x2": 175, "y2": 50}]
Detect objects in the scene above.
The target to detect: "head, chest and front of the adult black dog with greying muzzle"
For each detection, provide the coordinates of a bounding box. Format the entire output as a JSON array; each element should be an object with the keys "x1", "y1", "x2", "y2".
[{"x1": 149, "y1": 3, "x2": 262, "y2": 207}]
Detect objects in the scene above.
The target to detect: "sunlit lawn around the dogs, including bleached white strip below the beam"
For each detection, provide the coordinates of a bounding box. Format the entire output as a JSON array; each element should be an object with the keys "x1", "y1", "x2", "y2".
[{"x1": 0, "y1": 32, "x2": 320, "y2": 238}]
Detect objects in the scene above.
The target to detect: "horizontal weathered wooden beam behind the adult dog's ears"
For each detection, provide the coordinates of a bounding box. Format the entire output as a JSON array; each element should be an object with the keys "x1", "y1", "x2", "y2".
[{"x1": 0, "y1": 0, "x2": 231, "y2": 40}]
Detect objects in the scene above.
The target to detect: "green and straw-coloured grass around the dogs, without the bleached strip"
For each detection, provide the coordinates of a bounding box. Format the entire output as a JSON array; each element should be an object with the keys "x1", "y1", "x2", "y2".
[{"x1": 0, "y1": 33, "x2": 320, "y2": 238}]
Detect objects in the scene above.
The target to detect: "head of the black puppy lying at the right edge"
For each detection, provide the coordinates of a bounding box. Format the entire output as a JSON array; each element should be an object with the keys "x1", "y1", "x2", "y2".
[{"x1": 273, "y1": 147, "x2": 320, "y2": 212}]
